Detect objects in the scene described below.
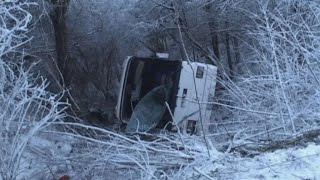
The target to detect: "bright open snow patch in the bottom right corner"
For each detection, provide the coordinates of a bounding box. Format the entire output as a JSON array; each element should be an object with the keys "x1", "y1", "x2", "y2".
[{"x1": 195, "y1": 143, "x2": 320, "y2": 180}]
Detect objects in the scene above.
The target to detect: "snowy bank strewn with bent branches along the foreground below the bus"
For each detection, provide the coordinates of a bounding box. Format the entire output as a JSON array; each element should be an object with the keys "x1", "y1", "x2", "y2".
[{"x1": 19, "y1": 131, "x2": 320, "y2": 180}]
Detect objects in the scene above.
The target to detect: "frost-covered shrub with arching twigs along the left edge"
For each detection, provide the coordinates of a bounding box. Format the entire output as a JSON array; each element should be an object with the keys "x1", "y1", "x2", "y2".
[{"x1": 0, "y1": 1, "x2": 65, "y2": 179}]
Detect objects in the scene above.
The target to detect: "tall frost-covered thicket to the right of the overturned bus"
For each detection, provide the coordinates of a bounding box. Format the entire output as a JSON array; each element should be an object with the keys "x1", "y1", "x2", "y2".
[{"x1": 212, "y1": 0, "x2": 320, "y2": 144}]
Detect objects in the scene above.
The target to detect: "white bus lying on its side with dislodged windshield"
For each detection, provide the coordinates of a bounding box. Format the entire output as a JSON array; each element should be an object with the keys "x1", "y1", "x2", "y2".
[{"x1": 116, "y1": 57, "x2": 217, "y2": 133}]
